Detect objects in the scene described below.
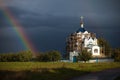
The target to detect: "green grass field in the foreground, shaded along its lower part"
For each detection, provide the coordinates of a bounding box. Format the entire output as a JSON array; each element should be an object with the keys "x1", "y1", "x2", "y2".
[{"x1": 0, "y1": 62, "x2": 120, "y2": 80}]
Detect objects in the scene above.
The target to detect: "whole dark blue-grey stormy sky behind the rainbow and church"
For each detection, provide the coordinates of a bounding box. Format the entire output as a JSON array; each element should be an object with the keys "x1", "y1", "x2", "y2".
[{"x1": 0, "y1": 0, "x2": 120, "y2": 53}]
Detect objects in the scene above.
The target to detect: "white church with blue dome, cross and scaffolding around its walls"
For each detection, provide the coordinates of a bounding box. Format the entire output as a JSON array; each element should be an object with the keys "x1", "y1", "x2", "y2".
[{"x1": 66, "y1": 17, "x2": 101, "y2": 62}]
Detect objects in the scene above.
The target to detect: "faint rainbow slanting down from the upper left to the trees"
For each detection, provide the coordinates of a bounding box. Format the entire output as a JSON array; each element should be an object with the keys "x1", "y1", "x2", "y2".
[{"x1": 0, "y1": 2, "x2": 37, "y2": 54}]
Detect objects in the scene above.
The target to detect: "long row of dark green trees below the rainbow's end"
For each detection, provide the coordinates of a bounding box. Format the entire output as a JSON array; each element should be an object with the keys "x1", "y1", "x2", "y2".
[{"x1": 0, "y1": 51, "x2": 61, "y2": 62}]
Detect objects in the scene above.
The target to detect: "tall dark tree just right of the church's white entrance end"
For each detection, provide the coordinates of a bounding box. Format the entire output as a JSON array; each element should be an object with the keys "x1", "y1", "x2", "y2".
[{"x1": 98, "y1": 37, "x2": 111, "y2": 56}]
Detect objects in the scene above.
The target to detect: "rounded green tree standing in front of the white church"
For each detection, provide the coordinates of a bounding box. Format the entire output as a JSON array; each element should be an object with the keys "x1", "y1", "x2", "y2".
[{"x1": 78, "y1": 49, "x2": 92, "y2": 62}]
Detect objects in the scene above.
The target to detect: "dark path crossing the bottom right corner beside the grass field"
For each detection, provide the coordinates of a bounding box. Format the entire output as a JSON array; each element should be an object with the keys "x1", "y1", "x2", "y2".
[{"x1": 72, "y1": 68, "x2": 120, "y2": 80}]
